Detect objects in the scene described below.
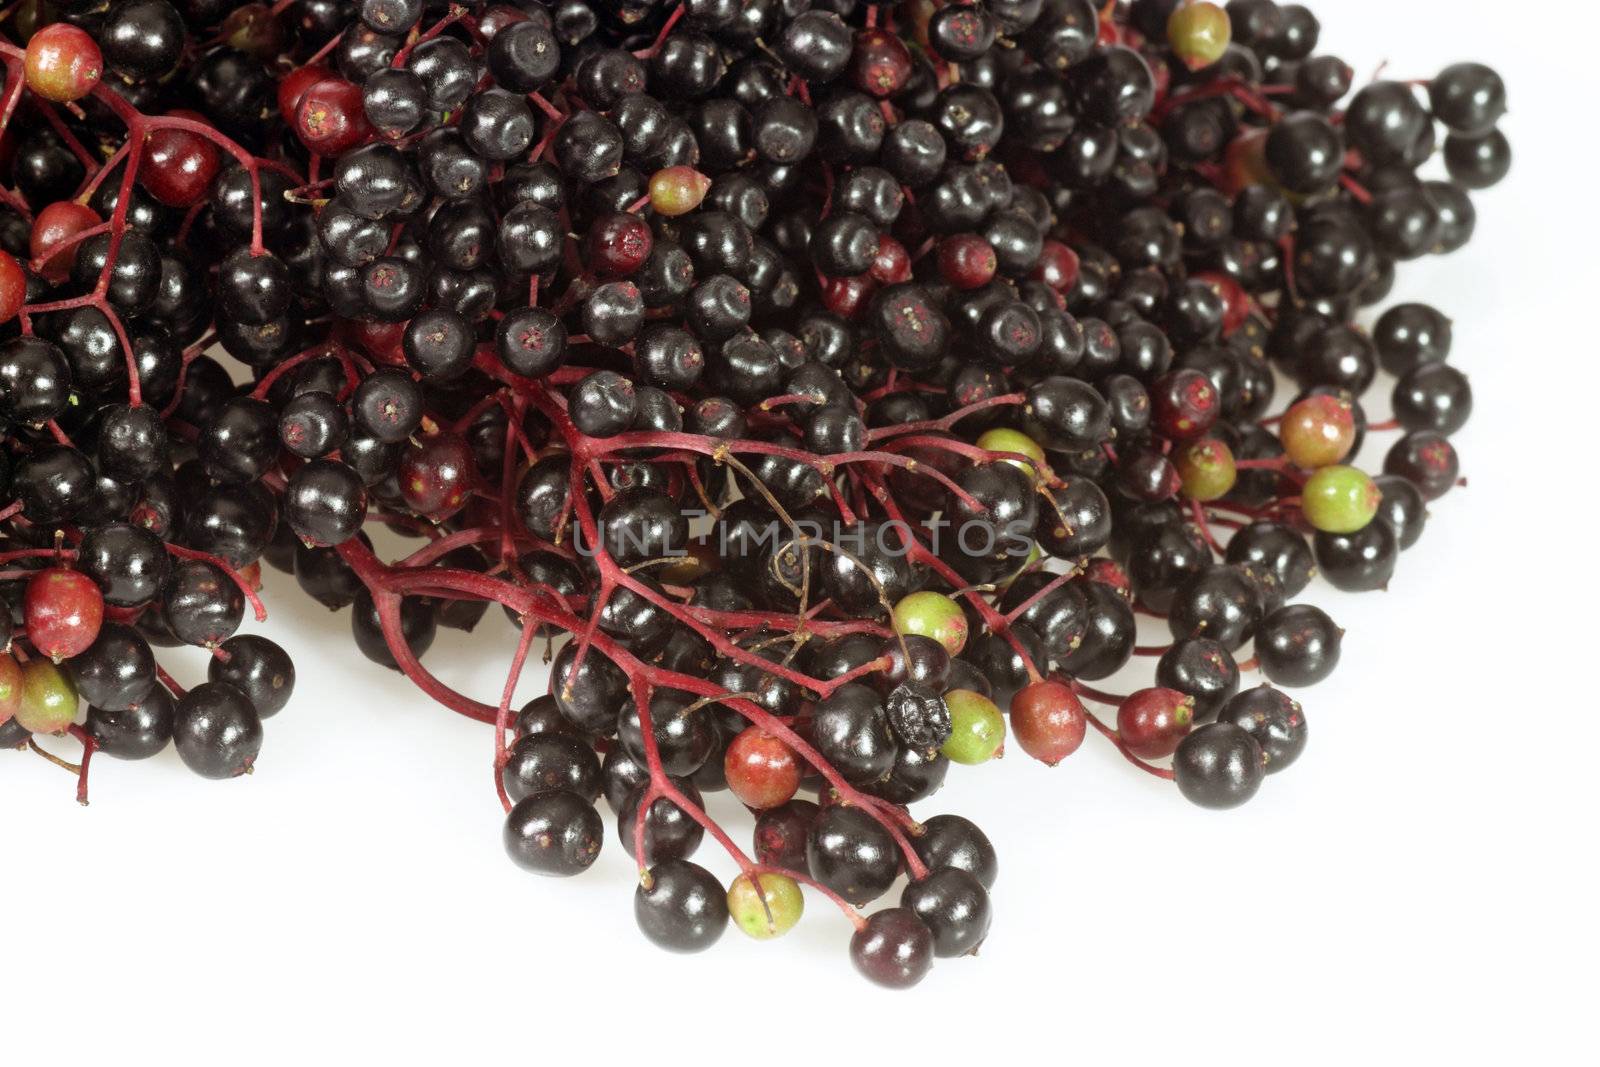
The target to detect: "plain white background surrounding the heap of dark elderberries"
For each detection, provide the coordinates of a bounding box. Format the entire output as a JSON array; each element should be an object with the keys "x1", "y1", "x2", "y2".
[{"x1": 0, "y1": 0, "x2": 1600, "y2": 1065}]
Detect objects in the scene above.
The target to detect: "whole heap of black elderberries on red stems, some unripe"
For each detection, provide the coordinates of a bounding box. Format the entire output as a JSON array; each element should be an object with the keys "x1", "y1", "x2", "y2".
[{"x1": 0, "y1": 0, "x2": 1510, "y2": 985}]
